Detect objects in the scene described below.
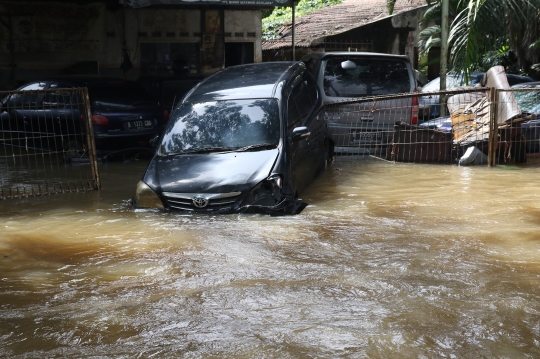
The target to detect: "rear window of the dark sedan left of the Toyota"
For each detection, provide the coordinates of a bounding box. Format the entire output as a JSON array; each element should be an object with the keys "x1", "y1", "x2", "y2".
[{"x1": 88, "y1": 83, "x2": 158, "y2": 110}]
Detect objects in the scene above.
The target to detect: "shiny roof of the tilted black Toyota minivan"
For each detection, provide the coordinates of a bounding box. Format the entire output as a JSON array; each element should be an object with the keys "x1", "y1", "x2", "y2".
[{"x1": 184, "y1": 61, "x2": 298, "y2": 102}]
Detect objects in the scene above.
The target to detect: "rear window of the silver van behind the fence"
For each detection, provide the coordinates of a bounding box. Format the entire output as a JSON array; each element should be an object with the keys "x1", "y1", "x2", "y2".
[{"x1": 323, "y1": 57, "x2": 411, "y2": 97}]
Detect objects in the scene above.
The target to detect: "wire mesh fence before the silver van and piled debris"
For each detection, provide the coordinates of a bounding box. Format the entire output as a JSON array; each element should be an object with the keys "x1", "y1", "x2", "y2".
[{"x1": 325, "y1": 87, "x2": 540, "y2": 166}]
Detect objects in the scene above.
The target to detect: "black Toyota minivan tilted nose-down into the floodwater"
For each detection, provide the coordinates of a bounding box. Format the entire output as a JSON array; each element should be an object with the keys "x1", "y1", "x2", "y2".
[{"x1": 133, "y1": 62, "x2": 333, "y2": 214}]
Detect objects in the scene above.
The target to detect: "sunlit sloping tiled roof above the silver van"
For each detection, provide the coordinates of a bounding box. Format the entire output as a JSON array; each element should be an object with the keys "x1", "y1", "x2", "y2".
[{"x1": 262, "y1": 0, "x2": 427, "y2": 50}]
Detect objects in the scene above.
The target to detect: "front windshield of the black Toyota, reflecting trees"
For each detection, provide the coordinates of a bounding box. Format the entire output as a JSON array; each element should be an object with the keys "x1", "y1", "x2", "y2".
[{"x1": 158, "y1": 99, "x2": 280, "y2": 156}]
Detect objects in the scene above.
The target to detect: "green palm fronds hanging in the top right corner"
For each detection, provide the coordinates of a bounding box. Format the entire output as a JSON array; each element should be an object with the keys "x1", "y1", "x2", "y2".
[{"x1": 419, "y1": 0, "x2": 540, "y2": 79}]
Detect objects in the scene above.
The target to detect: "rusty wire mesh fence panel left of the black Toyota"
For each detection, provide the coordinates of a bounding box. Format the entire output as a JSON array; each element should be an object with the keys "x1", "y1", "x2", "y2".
[{"x1": 0, "y1": 85, "x2": 101, "y2": 199}]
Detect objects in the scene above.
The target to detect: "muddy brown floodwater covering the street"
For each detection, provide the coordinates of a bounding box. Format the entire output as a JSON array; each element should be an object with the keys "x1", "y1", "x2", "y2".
[{"x1": 0, "y1": 158, "x2": 540, "y2": 358}]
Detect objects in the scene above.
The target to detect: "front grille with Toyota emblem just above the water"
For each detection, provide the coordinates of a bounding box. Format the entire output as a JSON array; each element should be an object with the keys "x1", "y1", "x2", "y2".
[{"x1": 163, "y1": 192, "x2": 241, "y2": 212}]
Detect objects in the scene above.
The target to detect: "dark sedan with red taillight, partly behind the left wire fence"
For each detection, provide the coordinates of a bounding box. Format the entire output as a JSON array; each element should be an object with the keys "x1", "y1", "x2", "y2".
[{"x1": 0, "y1": 76, "x2": 169, "y2": 160}]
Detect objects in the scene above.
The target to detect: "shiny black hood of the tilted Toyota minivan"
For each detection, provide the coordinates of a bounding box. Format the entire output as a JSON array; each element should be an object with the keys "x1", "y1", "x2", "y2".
[{"x1": 143, "y1": 149, "x2": 279, "y2": 193}]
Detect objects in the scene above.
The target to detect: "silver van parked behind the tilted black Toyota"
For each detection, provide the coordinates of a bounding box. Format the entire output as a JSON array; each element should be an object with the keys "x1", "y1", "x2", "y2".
[{"x1": 302, "y1": 52, "x2": 418, "y2": 155}]
